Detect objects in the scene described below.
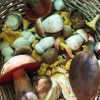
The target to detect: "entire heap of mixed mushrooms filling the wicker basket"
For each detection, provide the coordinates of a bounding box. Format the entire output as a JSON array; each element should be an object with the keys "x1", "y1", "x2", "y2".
[{"x1": 0, "y1": 0, "x2": 100, "y2": 100}]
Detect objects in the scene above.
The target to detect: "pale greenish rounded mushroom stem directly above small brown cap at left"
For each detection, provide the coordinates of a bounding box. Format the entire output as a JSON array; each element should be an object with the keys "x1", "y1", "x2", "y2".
[{"x1": 13, "y1": 37, "x2": 30, "y2": 49}]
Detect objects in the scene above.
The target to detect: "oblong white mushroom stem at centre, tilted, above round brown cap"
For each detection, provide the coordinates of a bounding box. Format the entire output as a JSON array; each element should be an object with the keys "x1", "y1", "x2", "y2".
[{"x1": 35, "y1": 37, "x2": 55, "y2": 54}]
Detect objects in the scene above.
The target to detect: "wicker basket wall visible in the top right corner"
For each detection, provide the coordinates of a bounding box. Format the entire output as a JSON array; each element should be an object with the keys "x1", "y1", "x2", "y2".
[{"x1": 63, "y1": 0, "x2": 100, "y2": 20}]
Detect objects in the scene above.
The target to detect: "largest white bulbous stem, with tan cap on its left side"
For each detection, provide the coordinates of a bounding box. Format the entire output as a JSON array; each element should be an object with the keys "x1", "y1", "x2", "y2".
[{"x1": 42, "y1": 14, "x2": 64, "y2": 33}]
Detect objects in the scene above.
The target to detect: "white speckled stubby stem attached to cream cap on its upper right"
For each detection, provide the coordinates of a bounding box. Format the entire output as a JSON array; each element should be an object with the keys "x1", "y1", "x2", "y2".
[{"x1": 66, "y1": 34, "x2": 84, "y2": 50}]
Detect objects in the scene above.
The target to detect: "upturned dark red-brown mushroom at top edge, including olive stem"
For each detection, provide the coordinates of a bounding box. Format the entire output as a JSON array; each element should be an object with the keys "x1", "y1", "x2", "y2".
[{"x1": 24, "y1": 0, "x2": 51, "y2": 20}]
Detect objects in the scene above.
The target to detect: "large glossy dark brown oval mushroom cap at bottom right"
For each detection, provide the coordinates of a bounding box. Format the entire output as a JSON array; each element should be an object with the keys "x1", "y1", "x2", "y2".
[{"x1": 69, "y1": 51, "x2": 100, "y2": 100}]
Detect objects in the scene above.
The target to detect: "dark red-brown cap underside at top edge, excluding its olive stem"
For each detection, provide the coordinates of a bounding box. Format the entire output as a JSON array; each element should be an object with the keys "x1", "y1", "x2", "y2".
[{"x1": 26, "y1": 0, "x2": 52, "y2": 20}]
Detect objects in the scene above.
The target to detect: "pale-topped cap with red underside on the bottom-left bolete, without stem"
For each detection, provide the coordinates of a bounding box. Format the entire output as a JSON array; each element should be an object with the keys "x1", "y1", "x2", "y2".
[{"x1": 0, "y1": 55, "x2": 40, "y2": 84}]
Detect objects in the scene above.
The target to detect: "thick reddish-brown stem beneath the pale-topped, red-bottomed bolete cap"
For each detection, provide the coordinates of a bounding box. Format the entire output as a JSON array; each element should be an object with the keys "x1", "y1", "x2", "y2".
[{"x1": 13, "y1": 69, "x2": 34, "y2": 100}]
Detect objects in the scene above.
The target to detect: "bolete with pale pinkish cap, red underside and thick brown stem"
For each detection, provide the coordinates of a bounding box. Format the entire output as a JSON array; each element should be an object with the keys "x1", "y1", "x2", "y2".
[{"x1": 0, "y1": 55, "x2": 39, "y2": 100}]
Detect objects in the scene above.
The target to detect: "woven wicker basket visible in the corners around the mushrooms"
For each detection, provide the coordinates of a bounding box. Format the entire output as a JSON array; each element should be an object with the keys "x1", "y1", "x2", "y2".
[{"x1": 0, "y1": 0, "x2": 100, "y2": 100}]
